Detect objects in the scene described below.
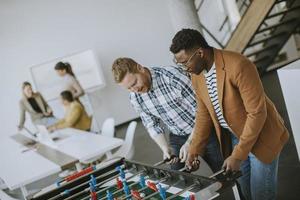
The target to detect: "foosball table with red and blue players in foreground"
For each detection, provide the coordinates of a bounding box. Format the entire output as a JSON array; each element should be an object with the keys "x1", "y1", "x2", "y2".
[{"x1": 29, "y1": 158, "x2": 241, "y2": 200}]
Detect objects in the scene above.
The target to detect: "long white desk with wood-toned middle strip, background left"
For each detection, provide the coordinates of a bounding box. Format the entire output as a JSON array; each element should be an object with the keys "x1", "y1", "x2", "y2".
[{"x1": 0, "y1": 128, "x2": 123, "y2": 198}]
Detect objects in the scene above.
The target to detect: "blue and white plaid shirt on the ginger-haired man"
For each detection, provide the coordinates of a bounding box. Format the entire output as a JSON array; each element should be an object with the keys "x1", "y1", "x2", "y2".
[{"x1": 130, "y1": 67, "x2": 197, "y2": 136}]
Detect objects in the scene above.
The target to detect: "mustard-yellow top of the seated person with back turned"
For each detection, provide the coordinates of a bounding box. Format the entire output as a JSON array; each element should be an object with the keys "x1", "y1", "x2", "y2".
[{"x1": 54, "y1": 101, "x2": 91, "y2": 131}]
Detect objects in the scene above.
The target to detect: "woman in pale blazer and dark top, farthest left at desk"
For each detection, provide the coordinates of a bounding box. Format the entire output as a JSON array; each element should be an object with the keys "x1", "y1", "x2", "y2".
[{"x1": 18, "y1": 82, "x2": 57, "y2": 130}]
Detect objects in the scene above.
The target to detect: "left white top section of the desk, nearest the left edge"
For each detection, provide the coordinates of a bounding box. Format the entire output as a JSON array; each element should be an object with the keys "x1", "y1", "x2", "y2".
[{"x1": 0, "y1": 138, "x2": 61, "y2": 190}]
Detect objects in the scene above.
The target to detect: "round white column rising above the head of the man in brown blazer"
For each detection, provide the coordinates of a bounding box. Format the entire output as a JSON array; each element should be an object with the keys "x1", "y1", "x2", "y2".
[{"x1": 167, "y1": 0, "x2": 202, "y2": 32}]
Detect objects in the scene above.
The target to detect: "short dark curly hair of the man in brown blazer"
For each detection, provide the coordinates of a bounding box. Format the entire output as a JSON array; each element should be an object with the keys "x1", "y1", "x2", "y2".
[{"x1": 170, "y1": 29, "x2": 211, "y2": 54}]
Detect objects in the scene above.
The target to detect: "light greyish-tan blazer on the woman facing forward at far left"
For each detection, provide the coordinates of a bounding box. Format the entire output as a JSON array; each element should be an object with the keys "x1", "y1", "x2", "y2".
[{"x1": 19, "y1": 92, "x2": 52, "y2": 127}]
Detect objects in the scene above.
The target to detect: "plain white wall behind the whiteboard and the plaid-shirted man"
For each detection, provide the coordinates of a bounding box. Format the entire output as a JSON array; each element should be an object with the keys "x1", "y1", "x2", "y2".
[{"x1": 0, "y1": 0, "x2": 174, "y2": 137}]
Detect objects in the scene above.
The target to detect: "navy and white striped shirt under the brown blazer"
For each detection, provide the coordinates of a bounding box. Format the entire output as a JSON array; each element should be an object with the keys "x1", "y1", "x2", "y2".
[{"x1": 204, "y1": 63, "x2": 232, "y2": 132}]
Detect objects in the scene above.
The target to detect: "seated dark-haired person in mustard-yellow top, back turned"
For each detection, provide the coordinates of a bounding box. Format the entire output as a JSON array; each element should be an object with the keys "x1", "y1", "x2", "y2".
[{"x1": 48, "y1": 91, "x2": 91, "y2": 132}]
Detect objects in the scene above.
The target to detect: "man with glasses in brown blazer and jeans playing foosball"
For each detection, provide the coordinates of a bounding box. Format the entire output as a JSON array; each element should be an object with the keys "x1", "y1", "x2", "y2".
[{"x1": 170, "y1": 29, "x2": 289, "y2": 200}]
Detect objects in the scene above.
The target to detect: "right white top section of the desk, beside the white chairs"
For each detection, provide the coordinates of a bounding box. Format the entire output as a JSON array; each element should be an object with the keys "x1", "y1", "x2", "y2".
[{"x1": 49, "y1": 128, "x2": 124, "y2": 163}]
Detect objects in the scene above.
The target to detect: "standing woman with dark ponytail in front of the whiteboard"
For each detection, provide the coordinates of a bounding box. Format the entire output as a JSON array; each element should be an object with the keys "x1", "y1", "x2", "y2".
[{"x1": 54, "y1": 62, "x2": 84, "y2": 99}]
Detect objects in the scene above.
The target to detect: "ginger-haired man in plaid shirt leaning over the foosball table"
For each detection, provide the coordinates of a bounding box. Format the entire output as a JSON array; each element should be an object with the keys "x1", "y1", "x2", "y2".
[{"x1": 112, "y1": 58, "x2": 223, "y2": 172}]
